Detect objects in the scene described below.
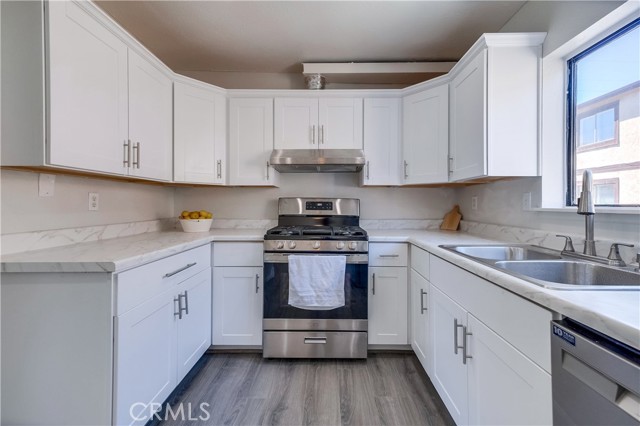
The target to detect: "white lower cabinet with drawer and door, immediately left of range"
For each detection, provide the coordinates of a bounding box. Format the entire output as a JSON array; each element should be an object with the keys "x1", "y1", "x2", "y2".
[{"x1": 211, "y1": 243, "x2": 264, "y2": 346}]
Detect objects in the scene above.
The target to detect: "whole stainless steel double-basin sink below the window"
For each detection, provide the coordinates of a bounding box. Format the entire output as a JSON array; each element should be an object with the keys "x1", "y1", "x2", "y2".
[{"x1": 440, "y1": 244, "x2": 640, "y2": 290}]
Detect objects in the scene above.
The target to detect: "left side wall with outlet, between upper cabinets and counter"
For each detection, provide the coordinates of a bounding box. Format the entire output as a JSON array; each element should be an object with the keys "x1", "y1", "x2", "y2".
[{"x1": 0, "y1": 170, "x2": 174, "y2": 234}]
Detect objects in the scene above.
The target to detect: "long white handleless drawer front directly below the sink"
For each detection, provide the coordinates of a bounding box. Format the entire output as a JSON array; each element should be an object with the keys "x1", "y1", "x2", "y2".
[{"x1": 430, "y1": 256, "x2": 553, "y2": 372}]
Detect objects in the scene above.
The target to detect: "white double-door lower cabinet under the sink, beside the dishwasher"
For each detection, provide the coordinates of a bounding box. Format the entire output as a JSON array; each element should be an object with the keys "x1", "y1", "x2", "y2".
[{"x1": 430, "y1": 256, "x2": 552, "y2": 425}]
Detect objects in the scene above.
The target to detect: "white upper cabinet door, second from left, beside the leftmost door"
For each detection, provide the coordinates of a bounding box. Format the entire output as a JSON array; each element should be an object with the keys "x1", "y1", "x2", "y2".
[{"x1": 129, "y1": 49, "x2": 173, "y2": 180}]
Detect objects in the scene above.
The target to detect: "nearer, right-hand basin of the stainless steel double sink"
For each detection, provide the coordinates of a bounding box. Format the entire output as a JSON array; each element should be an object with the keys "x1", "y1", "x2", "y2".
[{"x1": 495, "y1": 260, "x2": 640, "y2": 290}]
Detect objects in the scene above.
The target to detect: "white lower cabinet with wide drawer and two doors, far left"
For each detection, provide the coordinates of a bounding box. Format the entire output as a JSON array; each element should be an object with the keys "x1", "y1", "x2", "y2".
[{"x1": 113, "y1": 245, "x2": 211, "y2": 425}]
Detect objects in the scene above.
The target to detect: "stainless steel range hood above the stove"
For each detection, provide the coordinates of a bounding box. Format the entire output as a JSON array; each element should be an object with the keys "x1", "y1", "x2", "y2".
[{"x1": 270, "y1": 149, "x2": 365, "y2": 173}]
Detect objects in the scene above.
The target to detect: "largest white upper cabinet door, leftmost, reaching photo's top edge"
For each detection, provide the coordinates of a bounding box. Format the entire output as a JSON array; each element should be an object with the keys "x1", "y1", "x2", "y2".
[{"x1": 45, "y1": 1, "x2": 128, "y2": 174}]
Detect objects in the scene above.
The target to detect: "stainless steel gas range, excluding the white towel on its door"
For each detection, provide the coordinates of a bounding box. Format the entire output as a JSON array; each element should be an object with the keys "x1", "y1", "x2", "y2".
[{"x1": 263, "y1": 198, "x2": 369, "y2": 358}]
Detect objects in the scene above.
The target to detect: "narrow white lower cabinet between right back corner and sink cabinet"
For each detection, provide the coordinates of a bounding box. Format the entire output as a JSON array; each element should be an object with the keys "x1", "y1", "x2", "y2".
[{"x1": 409, "y1": 246, "x2": 433, "y2": 376}]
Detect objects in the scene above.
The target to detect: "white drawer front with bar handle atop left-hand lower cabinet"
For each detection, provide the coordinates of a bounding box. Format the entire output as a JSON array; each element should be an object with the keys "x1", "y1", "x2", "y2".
[{"x1": 116, "y1": 244, "x2": 211, "y2": 315}]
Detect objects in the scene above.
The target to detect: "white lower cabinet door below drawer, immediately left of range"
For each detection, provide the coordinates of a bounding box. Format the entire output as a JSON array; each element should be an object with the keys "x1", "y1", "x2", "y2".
[{"x1": 211, "y1": 267, "x2": 263, "y2": 346}]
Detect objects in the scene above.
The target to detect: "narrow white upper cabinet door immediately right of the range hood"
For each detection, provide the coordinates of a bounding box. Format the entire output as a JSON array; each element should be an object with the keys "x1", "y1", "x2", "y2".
[{"x1": 361, "y1": 98, "x2": 400, "y2": 186}]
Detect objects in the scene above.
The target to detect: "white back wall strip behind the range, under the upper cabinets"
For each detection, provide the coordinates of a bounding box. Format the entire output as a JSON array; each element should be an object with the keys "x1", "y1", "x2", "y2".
[{"x1": 174, "y1": 173, "x2": 455, "y2": 219}]
